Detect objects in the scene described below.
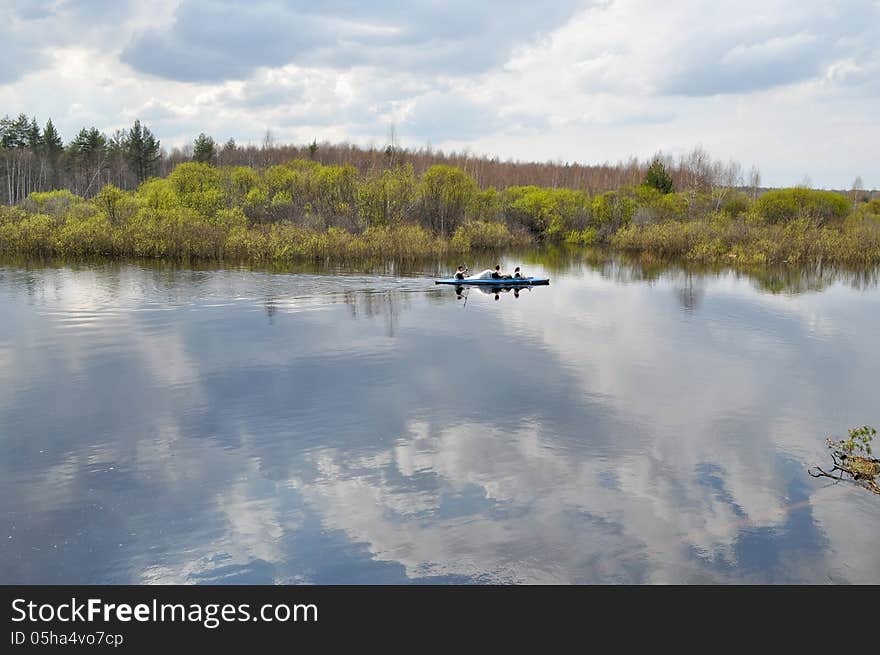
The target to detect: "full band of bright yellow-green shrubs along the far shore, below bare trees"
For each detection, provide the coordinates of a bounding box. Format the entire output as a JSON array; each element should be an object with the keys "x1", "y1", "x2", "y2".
[{"x1": 0, "y1": 160, "x2": 880, "y2": 266}]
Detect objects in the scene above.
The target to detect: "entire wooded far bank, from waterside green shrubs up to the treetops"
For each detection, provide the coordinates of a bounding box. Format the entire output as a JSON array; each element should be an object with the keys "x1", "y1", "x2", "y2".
[{"x1": 0, "y1": 115, "x2": 880, "y2": 266}]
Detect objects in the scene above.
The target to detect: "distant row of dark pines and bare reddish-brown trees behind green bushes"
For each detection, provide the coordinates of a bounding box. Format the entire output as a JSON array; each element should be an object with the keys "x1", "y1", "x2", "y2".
[{"x1": 17, "y1": 114, "x2": 868, "y2": 204}]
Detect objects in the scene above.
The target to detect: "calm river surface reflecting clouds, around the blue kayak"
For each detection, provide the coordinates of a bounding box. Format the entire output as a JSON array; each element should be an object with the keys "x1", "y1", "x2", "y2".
[{"x1": 0, "y1": 260, "x2": 880, "y2": 584}]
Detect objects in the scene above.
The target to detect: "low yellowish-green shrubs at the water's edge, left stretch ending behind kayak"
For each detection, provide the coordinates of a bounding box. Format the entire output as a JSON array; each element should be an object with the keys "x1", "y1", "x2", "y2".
[{"x1": 0, "y1": 212, "x2": 532, "y2": 263}]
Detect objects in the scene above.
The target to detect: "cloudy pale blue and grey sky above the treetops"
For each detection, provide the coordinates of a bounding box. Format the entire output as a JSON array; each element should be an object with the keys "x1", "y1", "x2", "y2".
[{"x1": 0, "y1": 0, "x2": 880, "y2": 188}]
